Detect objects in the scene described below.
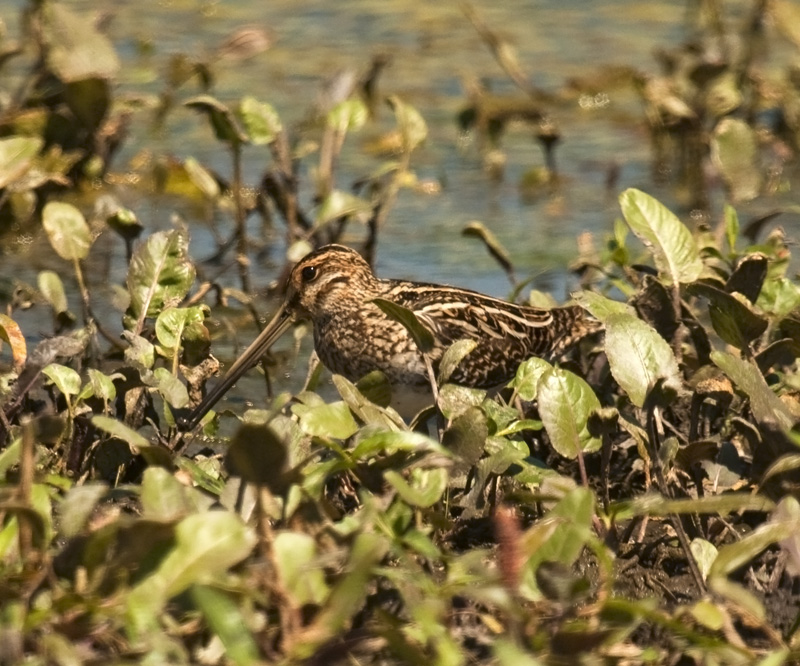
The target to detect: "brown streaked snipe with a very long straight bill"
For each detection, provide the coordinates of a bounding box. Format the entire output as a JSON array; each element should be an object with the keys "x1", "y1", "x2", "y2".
[{"x1": 183, "y1": 244, "x2": 600, "y2": 430}]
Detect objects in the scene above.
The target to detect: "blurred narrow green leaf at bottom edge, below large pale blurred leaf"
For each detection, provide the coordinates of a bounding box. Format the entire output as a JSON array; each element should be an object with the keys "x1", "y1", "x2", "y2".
[{"x1": 192, "y1": 585, "x2": 262, "y2": 666}]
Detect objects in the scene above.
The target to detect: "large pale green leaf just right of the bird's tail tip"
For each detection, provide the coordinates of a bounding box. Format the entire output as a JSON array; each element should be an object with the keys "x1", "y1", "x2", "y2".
[{"x1": 605, "y1": 314, "x2": 681, "y2": 407}]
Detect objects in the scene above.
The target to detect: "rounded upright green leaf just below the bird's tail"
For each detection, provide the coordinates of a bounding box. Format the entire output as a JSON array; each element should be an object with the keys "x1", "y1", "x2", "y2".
[{"x1": 537, "y1": 368, "x2": 601, "y2": 459}]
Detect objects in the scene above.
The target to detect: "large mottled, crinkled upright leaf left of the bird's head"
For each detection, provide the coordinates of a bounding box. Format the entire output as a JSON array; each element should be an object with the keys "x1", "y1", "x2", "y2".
[{"x1": 126, "y1": 229, "x2": 195, "y2": 321}]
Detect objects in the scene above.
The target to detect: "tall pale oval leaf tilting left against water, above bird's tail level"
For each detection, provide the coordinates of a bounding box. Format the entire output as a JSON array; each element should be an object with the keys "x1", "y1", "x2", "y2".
[{"x1": 619, "y1": 188, "x2": 703, "y2": 285}]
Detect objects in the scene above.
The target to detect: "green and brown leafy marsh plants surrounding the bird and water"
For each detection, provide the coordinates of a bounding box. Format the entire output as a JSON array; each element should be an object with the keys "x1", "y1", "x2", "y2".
[{"x1": 0, "y1": 2, "x2": 800, "y2": 665}]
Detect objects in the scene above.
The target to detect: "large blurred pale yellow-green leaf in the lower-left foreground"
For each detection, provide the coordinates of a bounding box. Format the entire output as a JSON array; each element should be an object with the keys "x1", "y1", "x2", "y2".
[{"x1": 126, "y1": 511, "x2": 256, "y2": 637}]
